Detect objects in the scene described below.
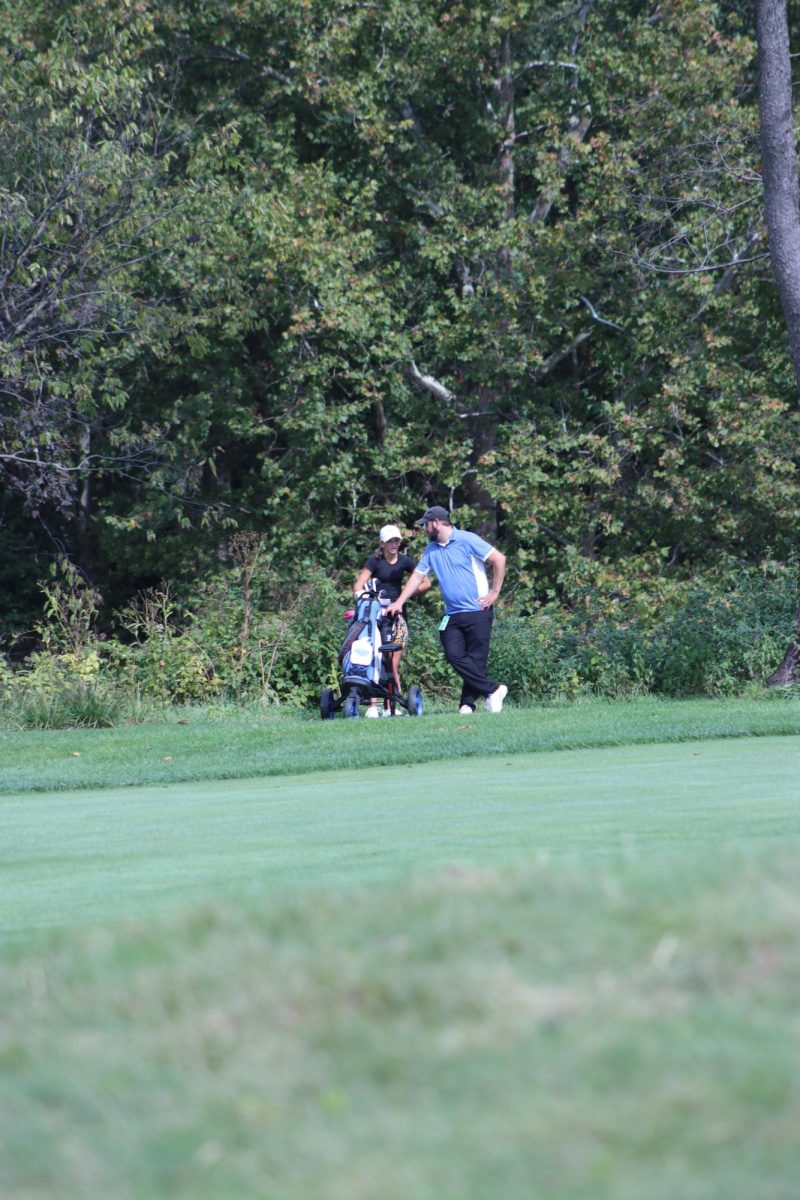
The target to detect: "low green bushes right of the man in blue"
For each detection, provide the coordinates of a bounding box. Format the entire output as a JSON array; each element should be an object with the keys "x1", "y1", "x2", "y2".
[{"x1": 506, "y1": 558, "x2": 798, "y2": 696}]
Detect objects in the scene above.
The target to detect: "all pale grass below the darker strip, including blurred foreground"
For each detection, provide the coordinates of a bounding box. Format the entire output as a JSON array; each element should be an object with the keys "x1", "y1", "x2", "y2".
[{"x1": 0, "y1": 704, "x2": 800, "y2": 1200}]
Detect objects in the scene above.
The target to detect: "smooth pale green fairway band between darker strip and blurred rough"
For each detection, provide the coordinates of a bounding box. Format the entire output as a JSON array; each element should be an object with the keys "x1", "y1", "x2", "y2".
[{"x1": 0, "y1": 737, "x2": 800, "y2": 931}]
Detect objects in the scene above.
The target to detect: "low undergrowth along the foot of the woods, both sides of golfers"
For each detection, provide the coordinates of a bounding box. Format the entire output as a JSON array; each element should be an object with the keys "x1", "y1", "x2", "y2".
[{"x1": 0, "y1": 554, "x2": 798, "y2": 728}]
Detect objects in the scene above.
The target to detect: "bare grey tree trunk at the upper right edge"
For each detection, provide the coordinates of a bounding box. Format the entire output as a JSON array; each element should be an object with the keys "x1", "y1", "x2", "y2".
[{"x1": 756, "y1": 0, "x2": 800, "y2": 389}]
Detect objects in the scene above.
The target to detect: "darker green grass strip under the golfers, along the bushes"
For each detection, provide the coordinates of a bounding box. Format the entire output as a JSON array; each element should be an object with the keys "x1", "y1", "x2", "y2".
[{"x1": 0, "y1": 694, "x2": 800, "y2": 792}]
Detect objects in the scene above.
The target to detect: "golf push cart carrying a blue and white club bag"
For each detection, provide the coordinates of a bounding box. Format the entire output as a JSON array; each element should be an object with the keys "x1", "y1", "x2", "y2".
[{"x1": 319, "y1": 580, "x2": 422, "y2": 721}]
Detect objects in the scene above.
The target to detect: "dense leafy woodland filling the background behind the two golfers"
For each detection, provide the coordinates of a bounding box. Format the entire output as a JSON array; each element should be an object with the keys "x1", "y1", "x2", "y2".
[{"x1": 0, "y1": 0, "x2": 800, "y2": 702}]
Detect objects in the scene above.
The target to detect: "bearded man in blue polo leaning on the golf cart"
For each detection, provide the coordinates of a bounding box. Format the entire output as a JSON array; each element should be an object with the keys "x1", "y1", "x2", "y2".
[{"x1": 386, "y1": 504, "x2": 509, "y2": 714}]
